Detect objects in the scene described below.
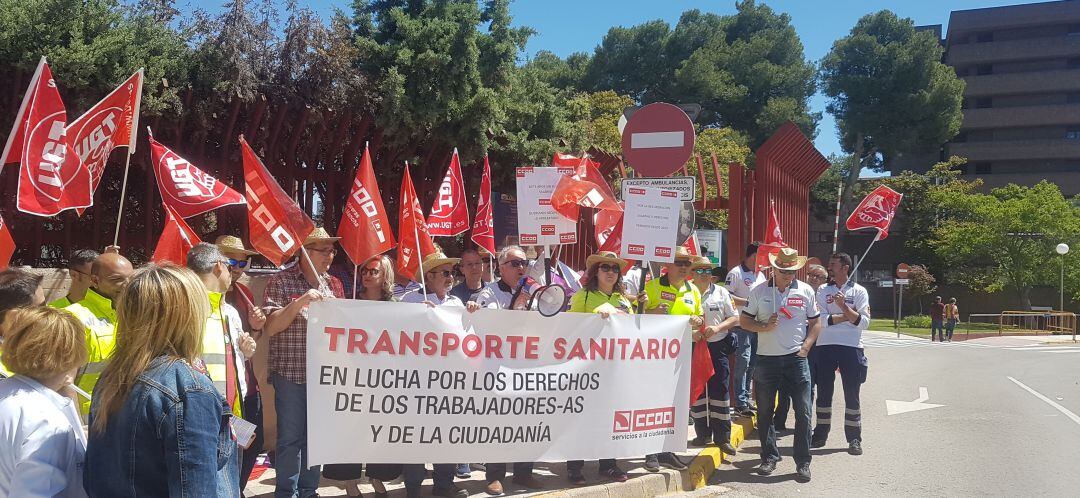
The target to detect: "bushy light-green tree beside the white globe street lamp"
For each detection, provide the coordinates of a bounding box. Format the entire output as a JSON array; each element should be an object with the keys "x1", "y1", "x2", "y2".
[{"x1": 931, "y1": 180, "x2": 1080, "y2": 310}]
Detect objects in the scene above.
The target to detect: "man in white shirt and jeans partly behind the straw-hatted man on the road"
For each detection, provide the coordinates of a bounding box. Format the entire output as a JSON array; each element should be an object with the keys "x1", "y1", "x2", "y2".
[{"x1": 727, "y1": 242, "x2": 765, "y2": 417}]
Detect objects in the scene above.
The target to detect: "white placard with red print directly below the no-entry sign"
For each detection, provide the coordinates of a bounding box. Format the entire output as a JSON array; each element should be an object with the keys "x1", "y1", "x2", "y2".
[{"x1": 620, "y1": 187, "x2": 683, "y2": 263}]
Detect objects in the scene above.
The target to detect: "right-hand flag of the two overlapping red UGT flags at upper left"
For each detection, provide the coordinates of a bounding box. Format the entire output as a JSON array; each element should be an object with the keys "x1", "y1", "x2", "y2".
[{"x1": 67, "y1": 69, "x2": 143, "y2": 211}]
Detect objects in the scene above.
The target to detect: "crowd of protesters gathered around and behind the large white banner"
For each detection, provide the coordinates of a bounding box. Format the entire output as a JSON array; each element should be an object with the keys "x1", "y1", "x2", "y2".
[{"x1": 0, "y1": 228, "x2": 876, "y2": 498}]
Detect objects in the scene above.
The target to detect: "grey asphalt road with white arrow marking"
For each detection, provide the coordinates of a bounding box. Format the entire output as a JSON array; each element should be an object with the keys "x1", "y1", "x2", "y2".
[{"x1": 694, "y1": 333, "x2": 1080, "y2": 497}]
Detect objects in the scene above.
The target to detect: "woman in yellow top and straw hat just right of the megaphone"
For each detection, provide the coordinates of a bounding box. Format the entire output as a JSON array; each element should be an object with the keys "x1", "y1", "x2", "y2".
[{"x1": 566, "y1": 251, "x2": 634, "y2": 486}]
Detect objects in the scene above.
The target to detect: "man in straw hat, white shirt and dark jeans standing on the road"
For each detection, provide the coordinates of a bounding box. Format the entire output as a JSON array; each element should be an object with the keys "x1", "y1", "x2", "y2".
[{"x1": 740, "y1": 247, "x2": 821, "y2": 482}]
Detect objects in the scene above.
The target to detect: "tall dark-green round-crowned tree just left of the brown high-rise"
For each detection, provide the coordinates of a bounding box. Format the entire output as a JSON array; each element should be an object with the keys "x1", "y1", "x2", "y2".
[{"x1": 821, "y1": 11, "x2": 964, "y2": 221}]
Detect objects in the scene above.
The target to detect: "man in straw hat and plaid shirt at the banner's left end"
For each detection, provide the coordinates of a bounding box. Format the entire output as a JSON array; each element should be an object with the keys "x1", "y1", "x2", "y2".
[{"x1": 264, "y1": 227, "x2": 345, "y2": 498}]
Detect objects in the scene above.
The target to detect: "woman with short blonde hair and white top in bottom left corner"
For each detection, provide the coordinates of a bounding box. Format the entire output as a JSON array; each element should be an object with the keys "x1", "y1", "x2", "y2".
[{"x1": 0, "y1": 308, "x2": 86, "y2": 498}]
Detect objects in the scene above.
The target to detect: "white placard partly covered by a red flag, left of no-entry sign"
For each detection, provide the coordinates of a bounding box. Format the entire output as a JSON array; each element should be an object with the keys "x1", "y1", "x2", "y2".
[{"x1": 517, "y1": 167, "x2": 578, "y2": 245}]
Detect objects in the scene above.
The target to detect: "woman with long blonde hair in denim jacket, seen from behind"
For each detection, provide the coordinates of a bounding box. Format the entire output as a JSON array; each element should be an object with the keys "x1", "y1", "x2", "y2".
[{"x1": 84, "y1": 265, "x2": 240, "y2": 498}]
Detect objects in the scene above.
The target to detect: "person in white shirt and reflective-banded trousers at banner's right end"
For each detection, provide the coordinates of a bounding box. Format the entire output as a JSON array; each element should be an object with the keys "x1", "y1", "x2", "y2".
[{"x1": 690, "y1": 256, "x2": 739, "y2": 455}]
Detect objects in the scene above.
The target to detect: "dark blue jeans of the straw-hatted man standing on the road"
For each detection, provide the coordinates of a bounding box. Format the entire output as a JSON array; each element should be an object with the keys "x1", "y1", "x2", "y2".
[{"x1": 754, "y1": 353, "x2": 810, "y2": 465}]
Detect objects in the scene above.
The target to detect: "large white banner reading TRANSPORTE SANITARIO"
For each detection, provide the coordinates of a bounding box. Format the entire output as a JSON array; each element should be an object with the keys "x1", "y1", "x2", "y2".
[{"x1": 307, "y1": 299, "x2": 691, "y2": 465}]
